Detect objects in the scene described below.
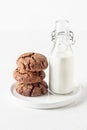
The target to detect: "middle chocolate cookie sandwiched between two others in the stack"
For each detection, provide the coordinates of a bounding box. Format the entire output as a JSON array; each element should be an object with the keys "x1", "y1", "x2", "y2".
[{"x1": 13, "y1": 69, "x2": 45, "y2": 84}]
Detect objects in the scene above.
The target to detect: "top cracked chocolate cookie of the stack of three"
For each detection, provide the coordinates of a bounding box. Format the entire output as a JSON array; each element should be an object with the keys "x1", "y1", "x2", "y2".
[{"x1": 16, "y1": 52, "x2": 48, "y2": 73}]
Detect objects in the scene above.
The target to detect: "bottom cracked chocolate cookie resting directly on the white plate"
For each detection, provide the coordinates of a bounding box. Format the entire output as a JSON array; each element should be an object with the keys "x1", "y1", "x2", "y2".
[{"x1": 16, "y1": 81, "x2": 48, "y2": 97}]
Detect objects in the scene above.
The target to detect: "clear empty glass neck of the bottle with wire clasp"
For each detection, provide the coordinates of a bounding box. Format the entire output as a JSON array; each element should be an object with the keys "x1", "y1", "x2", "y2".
[{"x1": 51, "y1": 20, "x2": 75, "y2": 53}]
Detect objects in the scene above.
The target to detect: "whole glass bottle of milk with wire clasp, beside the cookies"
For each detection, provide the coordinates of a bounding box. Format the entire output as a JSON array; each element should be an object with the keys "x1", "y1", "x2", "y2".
[{"x1": 49, "y1": 20, "x2": 74, "y2": 94}]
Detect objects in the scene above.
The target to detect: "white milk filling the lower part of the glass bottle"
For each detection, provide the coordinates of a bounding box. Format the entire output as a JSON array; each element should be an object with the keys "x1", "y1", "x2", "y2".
[{"x1": 49, "y1": 51, "x2": 74, "y2": 94}]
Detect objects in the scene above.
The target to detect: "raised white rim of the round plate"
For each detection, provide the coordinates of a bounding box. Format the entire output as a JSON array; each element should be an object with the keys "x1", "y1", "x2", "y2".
[{"x1": 10, "y1": 82, "x2": 82, "y2": 109}]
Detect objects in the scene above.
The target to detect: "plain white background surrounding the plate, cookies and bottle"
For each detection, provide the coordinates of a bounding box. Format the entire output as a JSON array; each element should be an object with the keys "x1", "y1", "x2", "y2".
[{"x1": 0, "y1": 0, "x2": 87, "y2": 130}]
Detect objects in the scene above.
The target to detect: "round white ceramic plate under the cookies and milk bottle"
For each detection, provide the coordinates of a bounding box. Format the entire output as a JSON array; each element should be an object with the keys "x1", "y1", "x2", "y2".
[{"x1": 10, "y1": 83, "x2": 82, "y2": 109}]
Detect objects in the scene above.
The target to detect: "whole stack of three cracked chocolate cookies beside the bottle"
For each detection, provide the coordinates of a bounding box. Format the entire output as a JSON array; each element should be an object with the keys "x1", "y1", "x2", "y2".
[{"x1": 13, "y1": 52, "x2": 48, "y2": 97}]
